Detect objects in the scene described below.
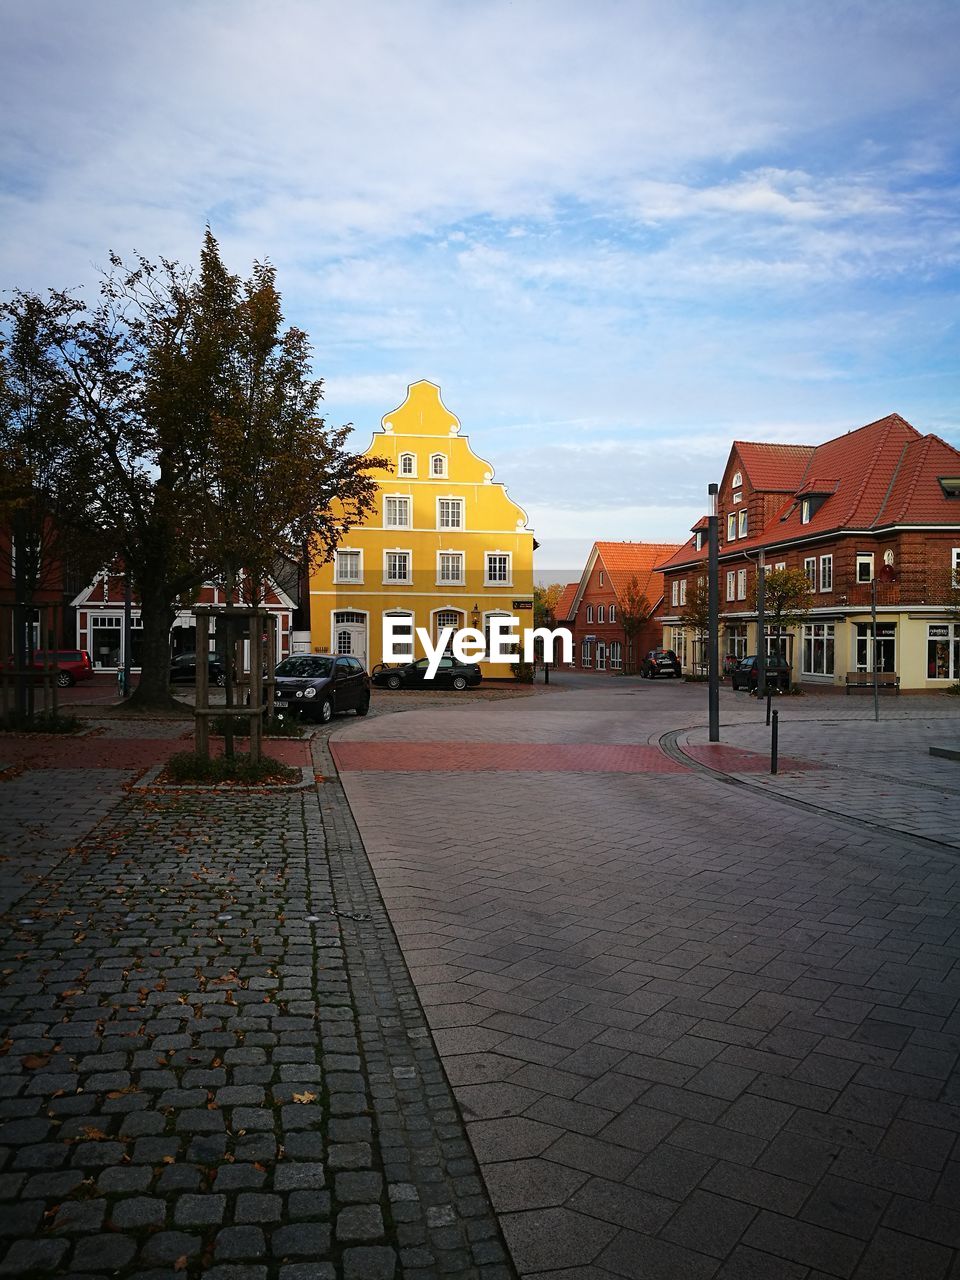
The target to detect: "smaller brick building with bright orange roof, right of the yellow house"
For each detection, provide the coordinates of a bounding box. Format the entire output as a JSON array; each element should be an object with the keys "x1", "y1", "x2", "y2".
[{"x1": 556, "y1": 543, "x2": 678, "y2": 673}]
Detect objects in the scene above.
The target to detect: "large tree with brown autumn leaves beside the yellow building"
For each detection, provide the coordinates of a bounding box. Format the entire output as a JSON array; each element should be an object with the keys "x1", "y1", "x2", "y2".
[{"x1": 0, "y1": 229, "x2": 376, "y2": 708}]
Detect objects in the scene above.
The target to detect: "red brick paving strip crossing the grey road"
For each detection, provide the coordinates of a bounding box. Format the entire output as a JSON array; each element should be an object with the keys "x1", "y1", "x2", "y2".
[{"x1": 330, "y1": 742, "x2": 687, "y2": 773}]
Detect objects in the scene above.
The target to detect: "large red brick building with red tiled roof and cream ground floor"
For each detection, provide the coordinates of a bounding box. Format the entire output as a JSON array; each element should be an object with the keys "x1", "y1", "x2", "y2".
[{"x1": 658, "y1": 413, "x2": 960, "y2": 689}]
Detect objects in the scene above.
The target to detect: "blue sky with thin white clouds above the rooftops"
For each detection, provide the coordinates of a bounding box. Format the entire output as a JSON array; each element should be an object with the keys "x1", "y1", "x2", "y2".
[{"x1": 0, "y1": 0, "x2": 960, "y2": 580}]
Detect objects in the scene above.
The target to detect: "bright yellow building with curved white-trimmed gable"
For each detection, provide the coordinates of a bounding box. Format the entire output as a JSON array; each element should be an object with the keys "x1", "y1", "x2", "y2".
[{"x1": 310, "y1": 381, "x2": 534, "y2": 678}]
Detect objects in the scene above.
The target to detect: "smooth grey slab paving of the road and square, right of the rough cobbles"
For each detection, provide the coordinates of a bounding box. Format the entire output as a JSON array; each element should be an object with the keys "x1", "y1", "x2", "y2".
[{"x1": 333, "y1": 682, "x2": 960, "y2": 1280}]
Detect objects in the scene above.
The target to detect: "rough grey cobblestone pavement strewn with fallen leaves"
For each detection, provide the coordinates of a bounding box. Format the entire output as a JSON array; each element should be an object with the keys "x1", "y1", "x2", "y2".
[{"x1": 0, "y1": 724, "x2": 515, "y2": 1280}]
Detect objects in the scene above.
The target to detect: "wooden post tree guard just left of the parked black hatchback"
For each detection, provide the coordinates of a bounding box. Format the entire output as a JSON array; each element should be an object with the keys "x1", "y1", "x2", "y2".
[{"x1": 191, "y1": 604, "x2": 267, "y2": 760}]
